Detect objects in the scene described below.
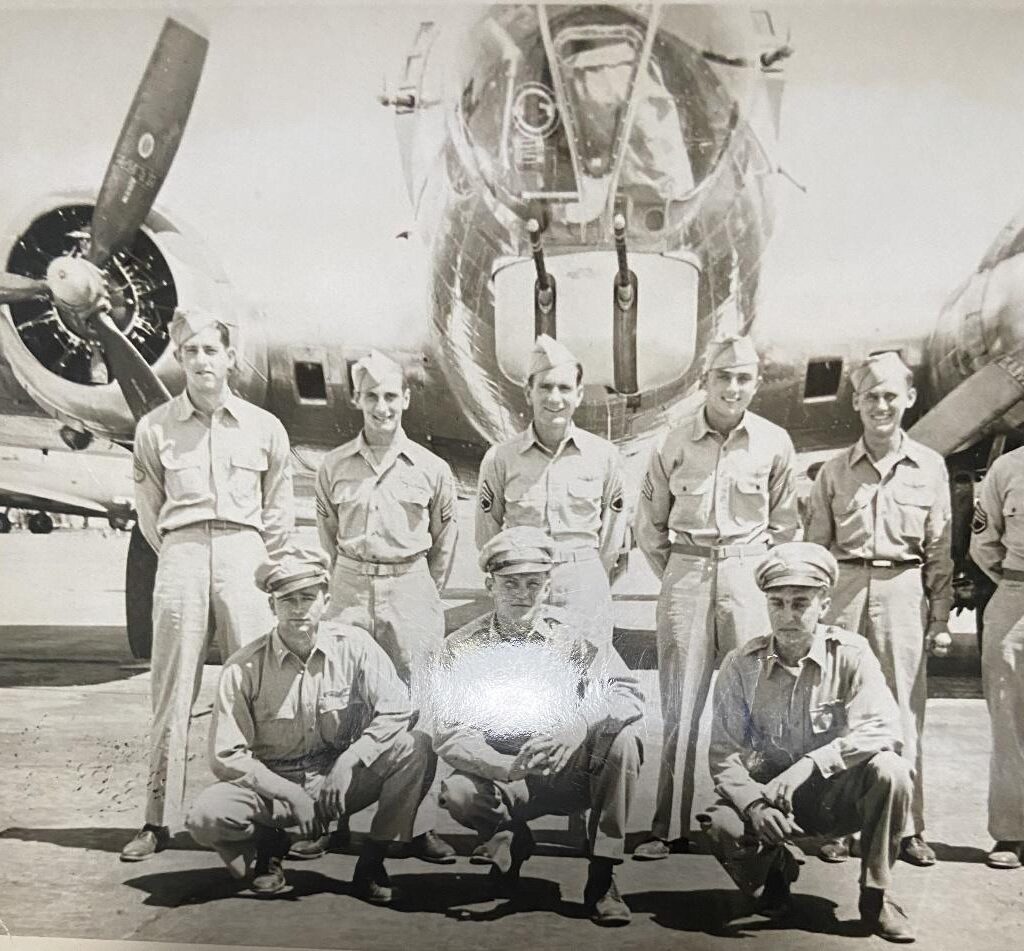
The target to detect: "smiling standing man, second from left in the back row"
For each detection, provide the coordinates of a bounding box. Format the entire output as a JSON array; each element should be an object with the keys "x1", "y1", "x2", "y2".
[{"x1": 313, "y1": 351, "x2": 458, "y2": 864}]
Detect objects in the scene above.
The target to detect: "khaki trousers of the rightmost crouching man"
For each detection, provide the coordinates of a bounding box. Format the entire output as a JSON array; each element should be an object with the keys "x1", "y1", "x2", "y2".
[{"x1": 697, "y1": 750, "x2": 912, "y2": 895}]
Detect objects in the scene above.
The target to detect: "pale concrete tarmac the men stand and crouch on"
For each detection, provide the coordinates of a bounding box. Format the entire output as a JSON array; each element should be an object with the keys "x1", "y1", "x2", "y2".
[{"x1": 0, "y1": 503, "x2": 1024, "y2": 951}]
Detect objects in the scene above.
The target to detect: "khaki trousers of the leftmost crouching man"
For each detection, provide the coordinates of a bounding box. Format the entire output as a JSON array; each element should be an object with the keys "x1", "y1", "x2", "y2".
[{"x1": 186, "y1": 731, "x2": 436, "y2": 866}]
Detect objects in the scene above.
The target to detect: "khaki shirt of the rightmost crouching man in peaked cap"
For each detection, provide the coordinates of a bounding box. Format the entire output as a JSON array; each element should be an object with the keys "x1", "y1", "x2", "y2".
[{"x1": 709, "y1": 624, "x2": 902, "y2": 812}]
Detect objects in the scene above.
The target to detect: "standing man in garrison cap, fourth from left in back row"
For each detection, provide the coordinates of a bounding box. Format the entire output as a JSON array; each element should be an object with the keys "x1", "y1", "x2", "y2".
[{"x1": 634, "y1": 337, "x2": 800, "y2": 860}]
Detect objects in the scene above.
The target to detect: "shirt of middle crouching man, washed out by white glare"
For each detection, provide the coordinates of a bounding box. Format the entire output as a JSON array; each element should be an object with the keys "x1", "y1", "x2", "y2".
[{"x1": 423, "y1": 608, "x2": 644, "y2": 781}]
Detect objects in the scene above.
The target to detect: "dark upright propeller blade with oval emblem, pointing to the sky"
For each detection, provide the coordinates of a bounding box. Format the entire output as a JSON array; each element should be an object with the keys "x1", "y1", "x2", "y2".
[{"x1": 88, "y1": 18, "x2": 208, "y2": 266}]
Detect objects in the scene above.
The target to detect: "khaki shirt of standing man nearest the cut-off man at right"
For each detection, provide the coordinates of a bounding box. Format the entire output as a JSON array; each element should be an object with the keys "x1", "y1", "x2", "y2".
[{"x1": 804, "y1": 433, "x2": 953, "y2": 622}]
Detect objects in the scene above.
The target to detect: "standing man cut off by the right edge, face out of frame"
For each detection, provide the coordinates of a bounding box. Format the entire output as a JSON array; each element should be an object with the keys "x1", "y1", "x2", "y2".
[{"x1": 971, "y1": 448, "x2": 1024, "y2": 868}]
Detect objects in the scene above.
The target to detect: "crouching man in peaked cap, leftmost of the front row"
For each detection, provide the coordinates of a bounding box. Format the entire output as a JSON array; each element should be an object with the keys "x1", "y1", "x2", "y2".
[{"x1": 188, "y1": 552, "x2": 436, "y2": 905}]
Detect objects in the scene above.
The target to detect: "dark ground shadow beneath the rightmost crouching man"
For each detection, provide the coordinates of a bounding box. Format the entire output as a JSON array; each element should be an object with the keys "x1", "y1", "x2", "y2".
[{"x1": 624, "y1": 889, "x2": 864, "y2": 938}]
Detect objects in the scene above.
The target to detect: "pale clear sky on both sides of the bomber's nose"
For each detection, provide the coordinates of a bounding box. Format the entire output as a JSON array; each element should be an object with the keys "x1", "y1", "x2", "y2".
[{"x1": 0, "y1": 0, "x2": 1024, "y2": 343}]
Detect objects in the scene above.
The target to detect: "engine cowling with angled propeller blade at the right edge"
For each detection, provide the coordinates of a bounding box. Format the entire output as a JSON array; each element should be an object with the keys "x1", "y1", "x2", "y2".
[{"x1": 910, "y1": 212, "x2": 1024, "y2": 456}]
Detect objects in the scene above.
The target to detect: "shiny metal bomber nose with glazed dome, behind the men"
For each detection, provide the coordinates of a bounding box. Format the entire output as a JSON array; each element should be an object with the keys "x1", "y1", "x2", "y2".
[{"x1": 398, "y1": 5, "x2": 777, "y2": 443}]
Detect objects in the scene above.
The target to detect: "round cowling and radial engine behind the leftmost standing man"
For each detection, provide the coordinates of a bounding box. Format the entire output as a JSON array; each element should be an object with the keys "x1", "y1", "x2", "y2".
[{"x1": 0, "y1": 192, "x2": 267, "y2": 443}]
